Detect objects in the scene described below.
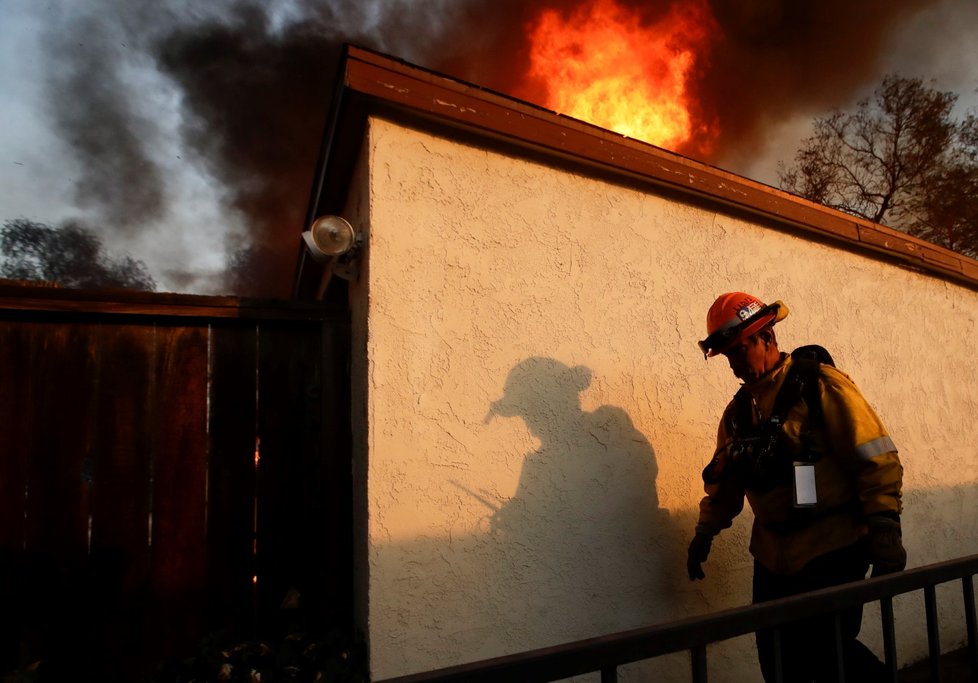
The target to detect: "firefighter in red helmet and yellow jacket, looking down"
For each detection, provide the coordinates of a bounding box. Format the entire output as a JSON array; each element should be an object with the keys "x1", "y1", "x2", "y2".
[{"x1": 687, "y1": 292, "x2": 907, "y2": 683}]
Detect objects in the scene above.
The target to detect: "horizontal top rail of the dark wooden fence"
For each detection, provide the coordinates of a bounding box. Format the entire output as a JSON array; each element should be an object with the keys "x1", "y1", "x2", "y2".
[{"x1": 0, "y1": 281, "x2": 346, "y2": 321}]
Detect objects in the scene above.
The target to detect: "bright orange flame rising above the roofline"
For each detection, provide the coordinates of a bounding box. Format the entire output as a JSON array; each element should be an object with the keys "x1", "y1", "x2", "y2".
[{"x1": 529, "y1": 0, "x2": 717, "y2": 153}]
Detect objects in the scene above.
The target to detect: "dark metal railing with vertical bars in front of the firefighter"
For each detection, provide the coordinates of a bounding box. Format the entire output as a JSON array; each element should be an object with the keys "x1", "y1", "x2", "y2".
[{"x1": 377, "y1": 555, "x2": 978, "y2": 683}]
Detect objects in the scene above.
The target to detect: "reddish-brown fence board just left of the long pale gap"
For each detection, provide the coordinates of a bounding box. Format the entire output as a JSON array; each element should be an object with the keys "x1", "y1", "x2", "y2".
[{"x1": 144, "y1": 326, "x2": 208, "y2": 674}]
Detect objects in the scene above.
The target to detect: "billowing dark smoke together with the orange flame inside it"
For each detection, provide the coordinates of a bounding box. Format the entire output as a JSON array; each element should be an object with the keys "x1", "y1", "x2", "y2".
[{"x1": 22, "y1": 0, "x2": 952, "y2": 296}]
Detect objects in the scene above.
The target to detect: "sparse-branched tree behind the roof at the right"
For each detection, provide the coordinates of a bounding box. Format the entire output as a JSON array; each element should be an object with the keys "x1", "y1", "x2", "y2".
[{"x1": 779, "y1": 75, "x2": 978, "y2": 256}]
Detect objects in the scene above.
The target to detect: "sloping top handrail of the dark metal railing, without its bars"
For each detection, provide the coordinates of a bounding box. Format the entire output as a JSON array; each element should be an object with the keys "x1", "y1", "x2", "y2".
[{"x1": 378, "y1": 555, "x2": 978, "y2": 683}]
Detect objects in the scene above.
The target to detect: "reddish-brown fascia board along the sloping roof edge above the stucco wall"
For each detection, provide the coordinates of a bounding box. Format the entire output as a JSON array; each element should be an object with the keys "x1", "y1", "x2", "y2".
[{"x1": 310, "y1": 46, "x2": 978, "y2": 287}]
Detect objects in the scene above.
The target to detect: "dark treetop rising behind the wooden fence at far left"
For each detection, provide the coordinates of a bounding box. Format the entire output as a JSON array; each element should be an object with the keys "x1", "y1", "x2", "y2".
[{"x1": 0, "y1": 218, "x2": 156, "y2": 290}]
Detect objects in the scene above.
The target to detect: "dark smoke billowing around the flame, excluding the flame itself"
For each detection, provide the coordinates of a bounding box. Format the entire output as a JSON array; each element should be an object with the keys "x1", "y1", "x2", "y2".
[{"x1": 36, "y1": 0, "x2": 944, "y2": 297}]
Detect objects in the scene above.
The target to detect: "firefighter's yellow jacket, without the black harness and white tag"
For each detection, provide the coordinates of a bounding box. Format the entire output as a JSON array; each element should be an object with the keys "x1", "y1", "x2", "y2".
[{"x1": 699, "y1": 354, "x2": 903, "y2": 574}]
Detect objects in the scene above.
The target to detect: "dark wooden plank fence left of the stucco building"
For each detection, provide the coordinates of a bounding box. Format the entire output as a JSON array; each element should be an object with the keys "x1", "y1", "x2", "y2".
[{"x1": 0, "y1": 287, "x2": 352, "y2": 680}]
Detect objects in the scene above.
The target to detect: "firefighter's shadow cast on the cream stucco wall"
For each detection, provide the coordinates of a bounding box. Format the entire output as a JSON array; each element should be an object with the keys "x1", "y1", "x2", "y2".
[{"x1": 486, "y1": 357, "x2": 679, "y2": 643}]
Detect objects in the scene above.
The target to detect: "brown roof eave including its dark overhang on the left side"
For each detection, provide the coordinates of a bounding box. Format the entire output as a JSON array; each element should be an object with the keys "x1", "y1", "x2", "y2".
[{"x1": 295, "y1": 46, "x2": 978, "y2": 298}]
